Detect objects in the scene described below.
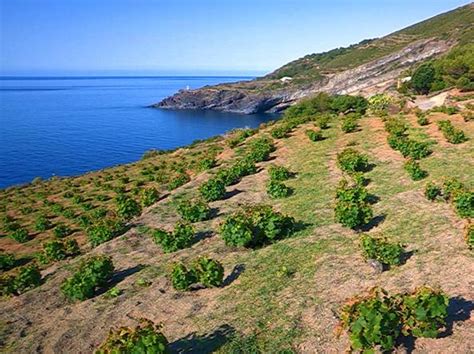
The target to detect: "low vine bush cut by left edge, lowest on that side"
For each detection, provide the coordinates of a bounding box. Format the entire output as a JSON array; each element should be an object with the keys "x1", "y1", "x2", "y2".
[{"x1": 0, "y1": 264, "x2": 41, "y2": 296}]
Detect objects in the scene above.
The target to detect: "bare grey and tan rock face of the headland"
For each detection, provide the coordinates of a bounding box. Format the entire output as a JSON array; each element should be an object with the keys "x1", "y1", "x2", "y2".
[{"x1": 153, "y1": 39, "x2": 453, "y2": 114}]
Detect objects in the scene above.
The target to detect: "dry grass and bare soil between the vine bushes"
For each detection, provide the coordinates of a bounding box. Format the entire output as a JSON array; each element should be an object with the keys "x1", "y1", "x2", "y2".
[{"x1": 2, "y1": 101, "x2": 474, "y2": 352}]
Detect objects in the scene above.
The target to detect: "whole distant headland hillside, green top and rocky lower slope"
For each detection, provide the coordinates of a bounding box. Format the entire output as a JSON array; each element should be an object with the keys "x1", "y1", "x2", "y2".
[{"x1": 154, "y1": 4, "x2": 474, "y2": 114}]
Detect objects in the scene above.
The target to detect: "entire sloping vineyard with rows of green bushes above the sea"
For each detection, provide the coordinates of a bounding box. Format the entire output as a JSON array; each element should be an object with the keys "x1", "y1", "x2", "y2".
[{"x1": 0, "y1": 91, "x2": 474, "y2": 353}]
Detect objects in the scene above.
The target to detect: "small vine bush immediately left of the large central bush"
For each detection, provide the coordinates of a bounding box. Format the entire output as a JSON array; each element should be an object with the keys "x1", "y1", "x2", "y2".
[{"x1": 152, "y1": 221, "x2": 194, "y2": 253}]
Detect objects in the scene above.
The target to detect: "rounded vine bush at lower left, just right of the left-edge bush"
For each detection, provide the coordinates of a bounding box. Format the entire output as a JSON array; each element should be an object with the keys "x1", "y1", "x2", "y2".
[{"x1": 61, "y1": 255, "x2": 114, "y2": 301}]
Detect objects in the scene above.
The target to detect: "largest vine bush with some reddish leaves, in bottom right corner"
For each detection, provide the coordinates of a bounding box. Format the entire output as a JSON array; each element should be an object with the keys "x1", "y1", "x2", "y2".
[{"x1": 340, "y1": 287, "x2": 448, "y2": 352}]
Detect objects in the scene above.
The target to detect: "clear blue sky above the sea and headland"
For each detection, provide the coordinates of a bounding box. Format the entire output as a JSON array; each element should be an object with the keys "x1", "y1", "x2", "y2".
[{"x1": 0, "y1": 0, "x2": 469, "y2": 76}]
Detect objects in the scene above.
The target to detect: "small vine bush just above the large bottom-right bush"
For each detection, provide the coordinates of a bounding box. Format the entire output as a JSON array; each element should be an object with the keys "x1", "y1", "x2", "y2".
[{"x1": 360, "y1": 235, "x2": 403, "y2": 266}]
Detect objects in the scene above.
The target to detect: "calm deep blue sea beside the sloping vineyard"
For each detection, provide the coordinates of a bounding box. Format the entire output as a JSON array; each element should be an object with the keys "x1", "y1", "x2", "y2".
[{"x1": 0, "y1": 77, "x2": 272, "y2": 188}]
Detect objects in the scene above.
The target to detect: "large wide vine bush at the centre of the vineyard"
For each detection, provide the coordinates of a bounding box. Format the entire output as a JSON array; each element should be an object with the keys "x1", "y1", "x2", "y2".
[{"x1": 220, "y1": 205, "x2": 295, "y2": 248}]
